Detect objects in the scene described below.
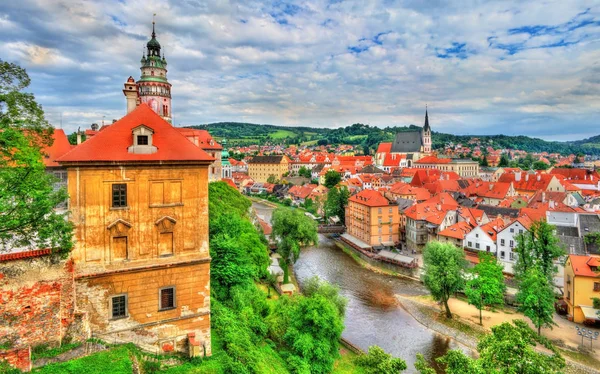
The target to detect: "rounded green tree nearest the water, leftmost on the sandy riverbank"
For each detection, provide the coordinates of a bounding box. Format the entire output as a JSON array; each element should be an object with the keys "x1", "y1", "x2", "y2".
[{"x1": 423, "y1": 241, "x2": 467, "y2": 318}]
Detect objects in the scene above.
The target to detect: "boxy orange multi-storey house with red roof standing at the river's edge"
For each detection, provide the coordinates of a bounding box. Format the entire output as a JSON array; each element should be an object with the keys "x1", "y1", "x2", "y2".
[{"x1": 346, "y1": 190, "x2": 400, "y2": 247}]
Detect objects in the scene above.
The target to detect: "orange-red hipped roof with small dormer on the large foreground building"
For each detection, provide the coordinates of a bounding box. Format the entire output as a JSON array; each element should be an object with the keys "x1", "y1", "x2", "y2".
[{"x1": 58, "y1": 104, "x2": 214, "y2": 163}]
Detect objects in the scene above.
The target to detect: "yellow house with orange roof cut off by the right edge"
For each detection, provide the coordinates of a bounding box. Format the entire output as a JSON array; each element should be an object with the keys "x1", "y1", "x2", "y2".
[{"x1": 565, "y1": 255, "x2": 600, "y2": 323}]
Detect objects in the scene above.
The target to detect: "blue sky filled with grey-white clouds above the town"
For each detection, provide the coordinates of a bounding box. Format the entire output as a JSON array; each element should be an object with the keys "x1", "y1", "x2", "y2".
[{"x1": 0, "y1": 0, "x2": 600, "y2": 140}]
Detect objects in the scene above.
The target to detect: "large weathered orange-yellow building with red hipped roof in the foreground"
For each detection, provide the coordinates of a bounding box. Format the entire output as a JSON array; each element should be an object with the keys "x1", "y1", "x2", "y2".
[{"x1": 58, "y1": 104, "x2": 214, "y2": 355}]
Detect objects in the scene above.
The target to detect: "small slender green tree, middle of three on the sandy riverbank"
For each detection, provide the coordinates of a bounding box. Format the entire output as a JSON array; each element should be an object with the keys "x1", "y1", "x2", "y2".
[{"x1": 465, "y1": 252, "x2": 506, "y2": 325}]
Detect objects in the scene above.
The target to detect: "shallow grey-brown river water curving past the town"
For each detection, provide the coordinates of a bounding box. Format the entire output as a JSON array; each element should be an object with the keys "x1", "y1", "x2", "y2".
[{"x1": 253, "y1": 203, "x2": 459, "y2": 373}]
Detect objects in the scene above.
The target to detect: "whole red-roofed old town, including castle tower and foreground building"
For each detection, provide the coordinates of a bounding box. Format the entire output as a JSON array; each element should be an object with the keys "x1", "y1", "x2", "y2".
[{"x1": 0, "y1": 22, "x2": 600, "y2": 370}]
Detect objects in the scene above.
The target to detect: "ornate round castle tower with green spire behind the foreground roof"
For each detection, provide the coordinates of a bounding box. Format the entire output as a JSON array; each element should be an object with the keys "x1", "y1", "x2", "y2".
[{"x1": 123, "y1": 21, "x2": 172, "y2": 123}]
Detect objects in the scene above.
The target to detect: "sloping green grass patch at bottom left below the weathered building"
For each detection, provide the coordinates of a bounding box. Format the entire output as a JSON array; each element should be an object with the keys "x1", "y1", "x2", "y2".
[{"x1": 32, "y1": 344, "x2": 137, "y2": 374}]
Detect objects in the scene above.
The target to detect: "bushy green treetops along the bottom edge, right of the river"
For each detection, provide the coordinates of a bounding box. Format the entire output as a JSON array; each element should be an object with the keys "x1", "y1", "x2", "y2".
[{"x1": 415, "y1": 320, "x2": 565, "y2": 374}]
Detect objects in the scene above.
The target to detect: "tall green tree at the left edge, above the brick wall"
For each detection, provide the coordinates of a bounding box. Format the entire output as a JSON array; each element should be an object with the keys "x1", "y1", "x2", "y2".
[{"x1": 0, "y1": 60, "x2": 73, "y2": 254}]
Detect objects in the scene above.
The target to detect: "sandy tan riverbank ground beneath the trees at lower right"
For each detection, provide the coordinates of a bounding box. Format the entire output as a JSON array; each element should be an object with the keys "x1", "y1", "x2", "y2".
[{"x1": 396, "y1": 295, "x2": 600, "y2": 374}]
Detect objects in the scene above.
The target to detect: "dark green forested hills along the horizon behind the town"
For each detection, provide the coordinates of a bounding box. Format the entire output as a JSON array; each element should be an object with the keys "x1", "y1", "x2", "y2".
[{"x1": 190, "y1": 122, "x2": 600, "y2": 155}]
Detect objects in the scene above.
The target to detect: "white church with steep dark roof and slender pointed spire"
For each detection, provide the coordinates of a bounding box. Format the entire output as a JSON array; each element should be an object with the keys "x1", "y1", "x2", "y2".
[{"x1": 375, "y1": 108, "x2": 432, "y2": 172}]
